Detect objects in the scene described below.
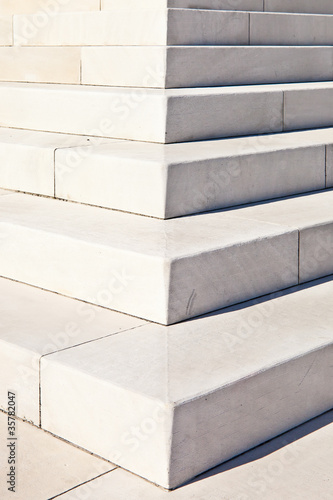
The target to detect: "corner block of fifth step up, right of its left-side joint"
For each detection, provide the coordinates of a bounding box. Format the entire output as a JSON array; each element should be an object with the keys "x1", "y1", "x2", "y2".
[{"x1": 82, "y1": 46, "x2": 333, "y2": 88}]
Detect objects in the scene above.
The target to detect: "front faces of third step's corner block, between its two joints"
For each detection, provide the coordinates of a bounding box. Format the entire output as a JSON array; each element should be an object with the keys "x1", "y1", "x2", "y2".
[{"x1": 55, "y1": 144, "x2": 326, "y2": 219}]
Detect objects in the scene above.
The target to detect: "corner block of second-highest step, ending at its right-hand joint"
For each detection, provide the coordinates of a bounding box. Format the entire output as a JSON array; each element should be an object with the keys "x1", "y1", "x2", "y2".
[{"x1": 13, "y1": 10, "x2": 249, "y2": 45}]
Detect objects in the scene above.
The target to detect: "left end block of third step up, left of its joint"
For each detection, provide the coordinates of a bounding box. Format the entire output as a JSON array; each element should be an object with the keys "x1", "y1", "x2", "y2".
[{"x1": 0, "y1": 128, "x2": 118, "y2": 196}]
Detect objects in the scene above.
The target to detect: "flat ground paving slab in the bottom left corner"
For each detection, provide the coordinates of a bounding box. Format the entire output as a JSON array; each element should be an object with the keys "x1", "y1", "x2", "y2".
[{"x1": 0, "y1": 410, "x2": 115, "y2": 500}]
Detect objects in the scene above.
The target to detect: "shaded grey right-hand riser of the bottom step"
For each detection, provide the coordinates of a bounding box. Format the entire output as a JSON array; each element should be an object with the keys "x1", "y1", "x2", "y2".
[{"x1": 169, "y1": 345, "x2": 333, "y2": 487}]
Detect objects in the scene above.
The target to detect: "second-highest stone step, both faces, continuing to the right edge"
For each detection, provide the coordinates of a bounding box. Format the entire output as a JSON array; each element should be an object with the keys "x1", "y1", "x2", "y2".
[{"x1": 13, "y1": 8, "x2": 333, "y2": 46}]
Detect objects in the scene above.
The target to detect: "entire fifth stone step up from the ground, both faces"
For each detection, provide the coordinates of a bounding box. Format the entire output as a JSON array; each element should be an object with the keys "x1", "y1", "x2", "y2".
[{"x1": 0, "y1": 46, "x2": 333, "y2": 88}]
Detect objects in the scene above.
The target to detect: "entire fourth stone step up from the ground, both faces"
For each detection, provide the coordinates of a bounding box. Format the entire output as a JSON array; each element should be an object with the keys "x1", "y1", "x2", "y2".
[{"x1": 0, "y1": 82, "x2": 333, "y2": 143}]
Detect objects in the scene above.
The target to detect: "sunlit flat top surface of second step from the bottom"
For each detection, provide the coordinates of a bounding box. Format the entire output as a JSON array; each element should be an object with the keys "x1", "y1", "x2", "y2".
[{"x1": 0, "y1": 192, "x2": 294, "y2": 259}]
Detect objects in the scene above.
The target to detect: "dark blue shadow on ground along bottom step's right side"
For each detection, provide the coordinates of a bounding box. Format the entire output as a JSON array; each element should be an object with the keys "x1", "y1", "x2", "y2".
[{"x1": 184, "y1": 410, "x2": 333, "y2": 486}]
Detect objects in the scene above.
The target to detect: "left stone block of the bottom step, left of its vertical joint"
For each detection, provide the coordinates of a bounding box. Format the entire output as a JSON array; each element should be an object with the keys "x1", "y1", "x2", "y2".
[{"x1": 0, "y1": 276, "x2": 144, "y2": 425}]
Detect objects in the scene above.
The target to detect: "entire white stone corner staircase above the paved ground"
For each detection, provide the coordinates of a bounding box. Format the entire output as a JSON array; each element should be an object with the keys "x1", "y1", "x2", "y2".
[{"x1": 0, "y1": 0, "x2": 333, "y2": 489}]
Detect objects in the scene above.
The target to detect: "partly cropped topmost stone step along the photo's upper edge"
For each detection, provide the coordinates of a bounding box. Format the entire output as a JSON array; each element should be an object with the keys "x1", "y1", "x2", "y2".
[{"x1": 102, "y1": 0, "x2": 333, "y2": 14}]
